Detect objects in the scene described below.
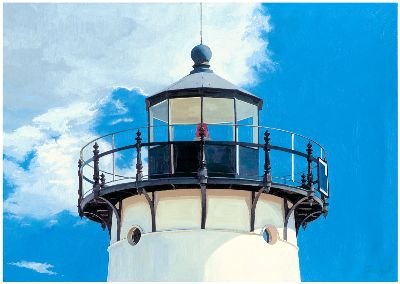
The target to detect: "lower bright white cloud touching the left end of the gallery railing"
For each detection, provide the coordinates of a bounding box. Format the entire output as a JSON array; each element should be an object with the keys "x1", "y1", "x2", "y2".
[{"x1": 3, "y1": 130, "x2": 93, "y2": 219}]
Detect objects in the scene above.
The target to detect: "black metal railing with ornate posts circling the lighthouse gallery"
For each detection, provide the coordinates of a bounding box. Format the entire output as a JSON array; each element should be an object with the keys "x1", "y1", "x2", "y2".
[{"x1": 78, "y1": 124, "x2": 327, "y2": 202}]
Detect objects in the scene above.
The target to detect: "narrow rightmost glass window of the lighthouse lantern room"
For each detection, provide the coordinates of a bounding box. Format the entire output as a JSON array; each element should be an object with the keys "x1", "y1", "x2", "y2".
[{"x1": 236, "y1": 100, "x2": 258, "y2": 143}]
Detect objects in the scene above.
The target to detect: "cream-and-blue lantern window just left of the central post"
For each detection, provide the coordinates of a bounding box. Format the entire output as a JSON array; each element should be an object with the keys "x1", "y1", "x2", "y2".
[{"x1": 169, "y1": 97, "x2": 201, "y2": 141}]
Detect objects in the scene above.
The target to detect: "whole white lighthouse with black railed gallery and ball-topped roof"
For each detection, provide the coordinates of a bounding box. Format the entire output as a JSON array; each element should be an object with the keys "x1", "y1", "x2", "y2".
[{"x1": 78, "y1": 44, "x2": 329, "y2": 281}]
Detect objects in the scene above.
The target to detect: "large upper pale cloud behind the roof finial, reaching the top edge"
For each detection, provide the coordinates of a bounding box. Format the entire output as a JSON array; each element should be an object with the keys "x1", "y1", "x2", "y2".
[{"x1": 4, "y1": 3, "x2": 271, "y2": 130}]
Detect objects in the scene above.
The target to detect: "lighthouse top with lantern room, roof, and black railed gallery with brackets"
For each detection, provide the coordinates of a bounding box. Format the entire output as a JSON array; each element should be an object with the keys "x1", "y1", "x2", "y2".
[{"x1": 78, "y1": 41, "x2": 329, "y2": 246}]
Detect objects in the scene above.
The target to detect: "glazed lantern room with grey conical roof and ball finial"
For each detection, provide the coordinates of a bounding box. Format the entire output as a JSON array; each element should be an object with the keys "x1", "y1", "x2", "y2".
[{"x1": 146, "y1": 44, "x2": 262, "y2": 177}]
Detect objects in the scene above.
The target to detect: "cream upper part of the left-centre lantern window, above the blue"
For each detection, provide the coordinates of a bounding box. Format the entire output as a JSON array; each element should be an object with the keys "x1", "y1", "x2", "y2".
[{"x1": 170, "y1": 97, "x2": 201, "y2": 125}]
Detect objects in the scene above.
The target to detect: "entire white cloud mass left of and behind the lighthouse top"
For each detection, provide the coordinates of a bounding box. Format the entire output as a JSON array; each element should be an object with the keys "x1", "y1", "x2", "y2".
[{"x1": 4, "y1": 4, "x2": 272, "y2": 219}]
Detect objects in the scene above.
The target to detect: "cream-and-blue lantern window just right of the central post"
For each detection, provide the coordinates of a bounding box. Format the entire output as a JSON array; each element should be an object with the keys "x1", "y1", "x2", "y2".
[{"x1": 203, "y1": 97, "x2": 235, "y2": 141}]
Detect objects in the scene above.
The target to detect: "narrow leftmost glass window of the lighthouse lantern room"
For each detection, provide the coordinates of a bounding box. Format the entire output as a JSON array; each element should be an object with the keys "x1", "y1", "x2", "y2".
[{"x1": 149, "y1": 100, "x2": 168, "y2": 142}]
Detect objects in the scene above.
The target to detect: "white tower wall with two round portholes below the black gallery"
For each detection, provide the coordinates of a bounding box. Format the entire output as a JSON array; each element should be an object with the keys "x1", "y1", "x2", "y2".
[{"x1": 108, "y1": 189, "x2": 300, "y2": 281}]
